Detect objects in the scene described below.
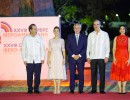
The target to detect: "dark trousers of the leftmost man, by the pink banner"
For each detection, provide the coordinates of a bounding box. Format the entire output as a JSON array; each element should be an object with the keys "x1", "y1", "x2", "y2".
[{"x1": 26, "y1": 63, "x2": 41, "y2": 91}]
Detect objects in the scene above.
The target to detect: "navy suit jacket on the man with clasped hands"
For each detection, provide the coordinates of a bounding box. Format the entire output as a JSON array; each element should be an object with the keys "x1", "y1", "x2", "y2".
[{"x1": 66, "y1": 33, "x2": 87, "y2": 63}]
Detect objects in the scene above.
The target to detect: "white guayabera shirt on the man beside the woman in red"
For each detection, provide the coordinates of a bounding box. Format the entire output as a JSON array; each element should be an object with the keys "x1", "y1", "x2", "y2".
[{"x1": 87, "y1": 30, "x2": 110, "y2": 59}]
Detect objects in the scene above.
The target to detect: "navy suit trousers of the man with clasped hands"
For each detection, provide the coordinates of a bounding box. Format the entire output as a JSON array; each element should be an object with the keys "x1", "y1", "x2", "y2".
[{"x1": 69, "y1": 62, "x2": 84, "y2": 91}]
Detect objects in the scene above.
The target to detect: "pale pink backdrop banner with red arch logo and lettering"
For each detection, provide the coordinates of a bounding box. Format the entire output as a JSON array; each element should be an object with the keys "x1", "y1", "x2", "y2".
[{"x1": 0, "y1": 16, "x2": 60, "y2": 80}]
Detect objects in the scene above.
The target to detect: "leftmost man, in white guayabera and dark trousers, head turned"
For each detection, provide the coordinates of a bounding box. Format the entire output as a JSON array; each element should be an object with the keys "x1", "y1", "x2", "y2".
[{"x1": 22, "y1": 24, "x2": 45, "y2": 94}]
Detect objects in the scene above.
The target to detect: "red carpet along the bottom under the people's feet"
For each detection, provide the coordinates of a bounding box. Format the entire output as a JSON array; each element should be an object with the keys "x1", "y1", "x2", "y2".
[{"x1": 0, "y1": 92, "x2": 130, "y2": 100}]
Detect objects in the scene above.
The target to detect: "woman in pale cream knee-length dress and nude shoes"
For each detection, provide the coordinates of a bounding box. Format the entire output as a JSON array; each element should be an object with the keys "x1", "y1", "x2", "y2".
[{"x1": 47, "y1": 26, "x2": 66, "y2": 94}]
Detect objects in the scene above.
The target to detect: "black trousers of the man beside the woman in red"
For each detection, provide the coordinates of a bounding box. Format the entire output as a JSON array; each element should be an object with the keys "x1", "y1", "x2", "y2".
[{"x1": 91, "y1": 59, "x2": 105, "y2": 91}]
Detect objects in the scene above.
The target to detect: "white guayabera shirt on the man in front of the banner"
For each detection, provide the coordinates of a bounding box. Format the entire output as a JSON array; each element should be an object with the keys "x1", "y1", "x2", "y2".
[{"x1": 22, "y1": 35, "x2": 46, "y2": 63}]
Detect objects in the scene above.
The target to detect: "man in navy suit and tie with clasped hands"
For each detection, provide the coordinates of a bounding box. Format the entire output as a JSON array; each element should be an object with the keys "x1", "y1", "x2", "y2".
[{"x1": 66, "y1": 23, "x2": 87, "y2": 94}]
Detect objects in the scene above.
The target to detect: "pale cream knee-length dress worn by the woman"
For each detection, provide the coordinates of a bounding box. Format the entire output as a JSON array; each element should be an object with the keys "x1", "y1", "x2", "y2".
[{"x1": 48, "y1": 38, "x2": 66, "y2": 80}]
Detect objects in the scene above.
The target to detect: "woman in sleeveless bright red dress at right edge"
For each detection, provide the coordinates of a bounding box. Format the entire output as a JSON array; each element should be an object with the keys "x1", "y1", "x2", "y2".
[{"x1": 110, "y1": 26, "x2": 130, "y2": 94}]
